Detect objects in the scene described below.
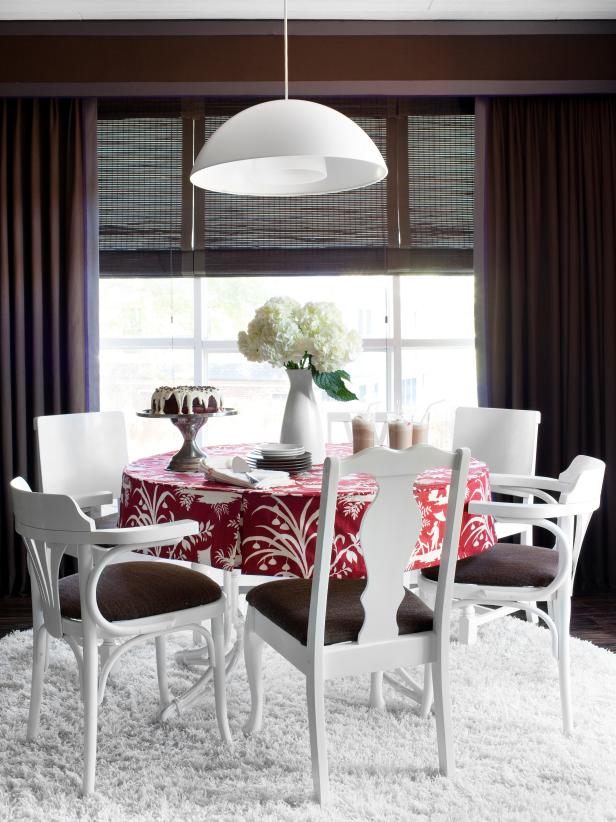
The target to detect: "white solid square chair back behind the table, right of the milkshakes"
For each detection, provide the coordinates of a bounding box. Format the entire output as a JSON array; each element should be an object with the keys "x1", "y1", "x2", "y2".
[{"x1": 452, "y1": 407, "x2": 541, "y2": 475}]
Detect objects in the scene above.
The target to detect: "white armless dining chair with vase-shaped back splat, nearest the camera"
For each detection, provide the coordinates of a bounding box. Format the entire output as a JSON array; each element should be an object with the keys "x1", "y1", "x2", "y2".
[{"x1": 244, "y1": 445, "x2": 470, "y2": 804}]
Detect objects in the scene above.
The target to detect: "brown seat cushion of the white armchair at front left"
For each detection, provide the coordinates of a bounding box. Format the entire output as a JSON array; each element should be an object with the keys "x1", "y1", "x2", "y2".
[{"x1": 58, "y1": 561, "x2": 222, "y2": 622}]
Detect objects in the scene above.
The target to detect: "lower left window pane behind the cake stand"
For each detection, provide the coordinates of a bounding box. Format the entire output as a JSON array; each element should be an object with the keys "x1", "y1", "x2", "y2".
[{"x1": 100, "y1": 348, "x2": 194, "y2": 459}]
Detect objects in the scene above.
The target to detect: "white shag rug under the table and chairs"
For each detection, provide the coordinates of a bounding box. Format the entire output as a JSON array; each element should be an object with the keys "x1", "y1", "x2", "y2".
[{"x1": 0, "y1": 619, "x2": 616, "y2": 822}]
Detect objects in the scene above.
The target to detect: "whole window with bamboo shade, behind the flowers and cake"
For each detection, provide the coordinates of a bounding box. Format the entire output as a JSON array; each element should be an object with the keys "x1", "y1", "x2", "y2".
[{"x1": 98, "y1": 98, "x2": 476, "y2": 455}]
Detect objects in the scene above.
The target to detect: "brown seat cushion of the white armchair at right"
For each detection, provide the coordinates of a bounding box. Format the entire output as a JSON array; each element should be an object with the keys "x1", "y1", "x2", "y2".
[{"x1": 421, "y1": 542, "x2": 558, "y2": 588}]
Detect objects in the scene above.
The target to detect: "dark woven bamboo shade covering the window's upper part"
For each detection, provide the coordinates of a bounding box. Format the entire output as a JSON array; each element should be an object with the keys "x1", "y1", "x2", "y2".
[{"x1": 98, "y1": 98, "x2": 474, "y2": 276}]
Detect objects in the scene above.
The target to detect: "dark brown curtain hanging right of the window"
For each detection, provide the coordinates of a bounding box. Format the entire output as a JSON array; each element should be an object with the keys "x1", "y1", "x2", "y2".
[{"x1": 476, "y1": 96, "x2": 616, "y2": 591}]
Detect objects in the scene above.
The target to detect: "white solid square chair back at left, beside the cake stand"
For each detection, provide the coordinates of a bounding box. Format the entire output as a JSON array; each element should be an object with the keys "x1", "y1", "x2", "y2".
[{"x1": 34, "y1": 411, "x2": 129, "y2": 498}]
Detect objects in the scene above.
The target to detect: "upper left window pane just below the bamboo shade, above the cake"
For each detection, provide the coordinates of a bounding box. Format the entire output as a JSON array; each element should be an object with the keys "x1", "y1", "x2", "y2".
[{"x1": 99, "y1": 277, "x2": 194, "y2": 339}]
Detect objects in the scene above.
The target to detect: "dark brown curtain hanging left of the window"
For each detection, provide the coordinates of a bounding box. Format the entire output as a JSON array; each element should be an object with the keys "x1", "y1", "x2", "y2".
[{"x1": 0, "y1": 99, "x2": 96, "y2": 595}]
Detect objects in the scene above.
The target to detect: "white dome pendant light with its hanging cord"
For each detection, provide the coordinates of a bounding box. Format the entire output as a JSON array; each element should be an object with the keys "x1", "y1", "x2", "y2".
[{"x1": 190, "y1": 0, "x2": 387, "y2": 197}]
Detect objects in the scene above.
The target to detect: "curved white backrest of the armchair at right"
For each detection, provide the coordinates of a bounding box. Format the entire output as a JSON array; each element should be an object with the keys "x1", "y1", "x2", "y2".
[{"x1": 558, "y1": 454, "x2": 605, "y2": 576}]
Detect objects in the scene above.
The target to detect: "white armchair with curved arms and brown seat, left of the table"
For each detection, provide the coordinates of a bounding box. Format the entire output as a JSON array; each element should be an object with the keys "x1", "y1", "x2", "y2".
[{"x1": 11, "y1": 477, "x2": 231, "y2": 795}]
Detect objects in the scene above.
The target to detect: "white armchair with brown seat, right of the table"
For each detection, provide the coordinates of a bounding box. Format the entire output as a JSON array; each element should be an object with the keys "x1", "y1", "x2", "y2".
[{"x1": 420, "y1": 455, "x2": 605, "y2": 734}]
